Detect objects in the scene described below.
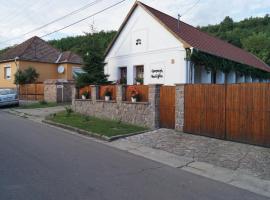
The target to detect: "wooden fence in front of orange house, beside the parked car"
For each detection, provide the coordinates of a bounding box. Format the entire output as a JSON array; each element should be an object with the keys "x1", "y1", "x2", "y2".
[{"x1": 19, "y1": 83, "x2": 44, "y2": 101}]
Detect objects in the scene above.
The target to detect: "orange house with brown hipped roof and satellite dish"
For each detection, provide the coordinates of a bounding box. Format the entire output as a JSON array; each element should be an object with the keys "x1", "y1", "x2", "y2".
[{"x1": 0, "y1": 37, "x2": 83, "y2": 88}]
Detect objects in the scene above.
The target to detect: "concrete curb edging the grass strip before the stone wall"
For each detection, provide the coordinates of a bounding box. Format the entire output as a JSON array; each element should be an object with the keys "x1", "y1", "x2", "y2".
[{"x1": 42, "y1": 120, "x2": 149, "y2": 142}]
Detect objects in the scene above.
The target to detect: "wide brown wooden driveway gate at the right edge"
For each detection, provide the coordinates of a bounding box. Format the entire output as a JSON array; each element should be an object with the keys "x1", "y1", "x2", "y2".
[{"x1": 184, "y1": 83, "x2": 270, "y2": 147}]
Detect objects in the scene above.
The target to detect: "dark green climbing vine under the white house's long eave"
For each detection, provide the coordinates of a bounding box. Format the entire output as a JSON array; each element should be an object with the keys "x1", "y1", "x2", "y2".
[{"x1": 190, "y1": 49, "x2": 270, "y2": 79}]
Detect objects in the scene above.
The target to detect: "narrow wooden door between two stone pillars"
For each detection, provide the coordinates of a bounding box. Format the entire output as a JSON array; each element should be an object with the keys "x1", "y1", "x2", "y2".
[{"x1": 160, "y1": 86, "x2": 175, "y2": 129}]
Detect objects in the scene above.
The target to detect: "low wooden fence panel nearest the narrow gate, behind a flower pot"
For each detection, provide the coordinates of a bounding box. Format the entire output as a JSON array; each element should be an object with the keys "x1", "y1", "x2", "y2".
[{"x1": 125, "y1": 85, "x2": 149, "y2": 102}]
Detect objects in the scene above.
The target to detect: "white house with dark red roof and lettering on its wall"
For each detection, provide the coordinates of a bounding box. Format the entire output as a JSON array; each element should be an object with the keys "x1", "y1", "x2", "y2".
[{"x1": 104, "y1": 2, "x2": 270, "y2": 85}]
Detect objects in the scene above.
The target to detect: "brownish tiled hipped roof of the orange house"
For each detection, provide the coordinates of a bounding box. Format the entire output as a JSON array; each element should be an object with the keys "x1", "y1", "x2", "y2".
[{"x1": 0, "y1": 36, "x2": 82, "y2": 64}]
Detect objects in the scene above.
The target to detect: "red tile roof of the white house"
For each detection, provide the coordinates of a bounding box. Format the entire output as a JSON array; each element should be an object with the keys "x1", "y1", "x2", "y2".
[{"x1": 105, "y1": 2, "x2": 270, "y2": 72}]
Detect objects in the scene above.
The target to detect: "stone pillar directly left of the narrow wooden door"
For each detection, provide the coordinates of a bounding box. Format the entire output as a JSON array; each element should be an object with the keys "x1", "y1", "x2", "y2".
[{"x1": 148, "y1": 84, "x2": 161, "y2": 129}]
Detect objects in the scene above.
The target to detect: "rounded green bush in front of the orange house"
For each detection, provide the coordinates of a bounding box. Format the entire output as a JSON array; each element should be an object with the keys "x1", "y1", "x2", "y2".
[{"x1": 14, "y1": 67, "x2": 39, "y2": 85}]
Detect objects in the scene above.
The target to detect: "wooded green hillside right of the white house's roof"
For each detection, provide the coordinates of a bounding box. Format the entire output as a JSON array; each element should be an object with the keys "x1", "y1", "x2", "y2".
[{"x1": 199, "y1": 15, "x2": 270, "y2": 65}]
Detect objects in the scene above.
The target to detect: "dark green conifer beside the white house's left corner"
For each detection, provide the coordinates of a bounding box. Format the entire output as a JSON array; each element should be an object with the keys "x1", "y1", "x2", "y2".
[{"x1": 76, "y1": 33, "x2": 108, "y2": 87}]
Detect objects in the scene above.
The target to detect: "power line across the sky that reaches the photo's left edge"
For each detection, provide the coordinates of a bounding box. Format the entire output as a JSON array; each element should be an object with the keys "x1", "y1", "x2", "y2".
[{"x1": 0, "y1": 0, "x2": 102, "y2": 44}]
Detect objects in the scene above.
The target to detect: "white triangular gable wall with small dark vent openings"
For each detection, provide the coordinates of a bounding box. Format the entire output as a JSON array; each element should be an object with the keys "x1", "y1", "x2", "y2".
[{"x1": 107, "y1": 4, "x2": 184, "y2": 59}]
